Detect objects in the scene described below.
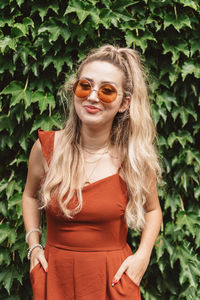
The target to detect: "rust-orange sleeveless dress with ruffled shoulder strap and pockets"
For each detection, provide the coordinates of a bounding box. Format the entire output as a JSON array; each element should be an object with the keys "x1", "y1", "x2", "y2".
[{"x1": 30, "y1": 130, "x2": 141, "y2": 300}]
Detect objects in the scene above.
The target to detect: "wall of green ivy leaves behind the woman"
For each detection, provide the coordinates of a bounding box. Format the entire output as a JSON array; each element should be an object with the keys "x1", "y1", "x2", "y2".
[{"x1": 0, "y1": 0, "x2": 200, "y2": 300}]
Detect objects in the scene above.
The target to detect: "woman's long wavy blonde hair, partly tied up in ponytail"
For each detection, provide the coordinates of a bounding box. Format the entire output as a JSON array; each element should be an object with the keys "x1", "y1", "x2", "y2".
[{"x1": 41, "y1": 45, "x2": 160, "y2": 230}]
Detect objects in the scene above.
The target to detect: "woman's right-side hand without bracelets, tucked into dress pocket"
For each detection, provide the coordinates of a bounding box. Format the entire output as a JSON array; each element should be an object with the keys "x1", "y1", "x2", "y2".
[{"x1": 113, "y1": 251, "x2": 150, "y2": 285}]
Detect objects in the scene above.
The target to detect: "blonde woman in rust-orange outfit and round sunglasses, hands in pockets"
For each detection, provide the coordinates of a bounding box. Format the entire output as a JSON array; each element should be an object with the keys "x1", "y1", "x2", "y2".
[{"x1": 23, "y1": 45, "x2": 162, "y2": 300}]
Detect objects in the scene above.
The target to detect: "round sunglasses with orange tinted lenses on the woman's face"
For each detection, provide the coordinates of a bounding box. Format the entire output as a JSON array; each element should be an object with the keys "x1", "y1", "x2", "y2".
[{"x1": 73, "y1": 79, "x2": 121, "y2": 103}]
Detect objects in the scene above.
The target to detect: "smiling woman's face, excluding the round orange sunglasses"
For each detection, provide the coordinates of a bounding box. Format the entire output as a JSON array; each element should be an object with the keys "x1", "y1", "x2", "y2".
[{"x1": 74, "y1": 61, "x2": 126, "y2": 129}]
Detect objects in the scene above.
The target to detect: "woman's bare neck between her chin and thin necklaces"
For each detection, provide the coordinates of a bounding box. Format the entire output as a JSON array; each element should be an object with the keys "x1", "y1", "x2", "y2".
[{"x1": 81, "y1": 126, "x2": 110, "y2": 150}]
